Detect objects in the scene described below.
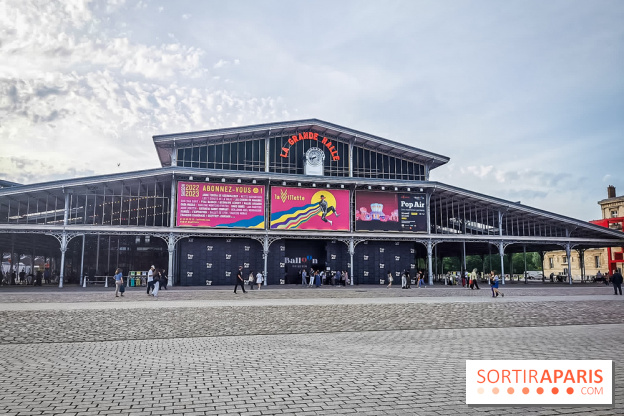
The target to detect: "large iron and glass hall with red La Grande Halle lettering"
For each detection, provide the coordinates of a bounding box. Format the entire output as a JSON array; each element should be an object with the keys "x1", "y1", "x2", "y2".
[{"x1": 0, "y1": 119, "x2": 624, "y2": 286}]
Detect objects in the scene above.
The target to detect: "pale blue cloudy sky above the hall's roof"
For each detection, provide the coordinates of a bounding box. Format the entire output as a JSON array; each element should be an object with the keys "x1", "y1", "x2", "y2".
[{"x1": 0, "y1": 0, "x2": 624, "y2": 220}]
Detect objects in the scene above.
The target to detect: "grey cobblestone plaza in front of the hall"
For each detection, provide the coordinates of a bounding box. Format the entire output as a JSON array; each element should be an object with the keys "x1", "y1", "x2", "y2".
[{"x1": 0, "y1": 283, "x2": 624, "y2": 415}]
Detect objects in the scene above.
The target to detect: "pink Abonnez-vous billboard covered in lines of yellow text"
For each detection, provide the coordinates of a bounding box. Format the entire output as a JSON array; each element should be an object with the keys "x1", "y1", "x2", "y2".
[{"x1": 176, "y1": 182, "x2": 265, "y2": 229}]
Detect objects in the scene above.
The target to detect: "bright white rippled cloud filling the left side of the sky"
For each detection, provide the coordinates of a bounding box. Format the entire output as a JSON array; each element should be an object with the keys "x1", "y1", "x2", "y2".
[{"x1": 0, "y1": 1, "x2": 282, "y2": 183}]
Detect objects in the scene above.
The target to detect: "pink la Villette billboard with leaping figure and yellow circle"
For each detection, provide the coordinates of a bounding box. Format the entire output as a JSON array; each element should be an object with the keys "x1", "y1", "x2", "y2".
[{"x1": 270, "y1": 186, "x2": 350, "y2": 231}]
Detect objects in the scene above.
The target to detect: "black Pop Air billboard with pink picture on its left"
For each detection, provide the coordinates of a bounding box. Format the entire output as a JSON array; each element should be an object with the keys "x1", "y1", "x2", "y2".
[{"x1": 355, "y1": 191, "x2": 427, "y2": 232}]
